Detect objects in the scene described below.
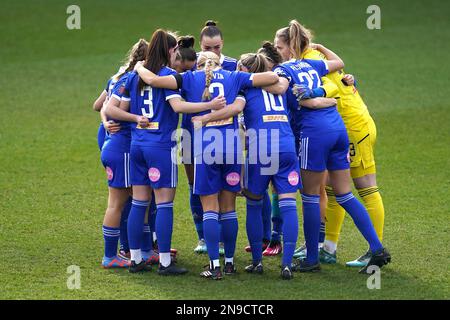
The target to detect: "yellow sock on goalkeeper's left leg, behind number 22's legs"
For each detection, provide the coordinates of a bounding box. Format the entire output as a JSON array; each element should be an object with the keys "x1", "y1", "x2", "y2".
[{"x1": 325, "y1": 186, "x2": 345, "y2": 243}]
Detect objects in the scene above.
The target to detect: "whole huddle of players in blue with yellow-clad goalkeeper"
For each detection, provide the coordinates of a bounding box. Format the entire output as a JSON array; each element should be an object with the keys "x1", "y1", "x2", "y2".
[{"x1": 94, "y1": 20, "x2": 391, "y2": 280}]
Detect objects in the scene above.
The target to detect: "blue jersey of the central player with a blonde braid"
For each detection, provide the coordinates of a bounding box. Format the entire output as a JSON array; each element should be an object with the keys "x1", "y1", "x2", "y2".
[{"x1": 175, "y1": 69, "x2": 253, "y2": 155}]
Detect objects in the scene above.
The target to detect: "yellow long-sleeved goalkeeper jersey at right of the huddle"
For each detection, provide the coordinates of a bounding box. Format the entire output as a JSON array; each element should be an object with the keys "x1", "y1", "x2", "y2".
[{"x1": 302, "y1": 48, "x2": 370, "y2": 130}]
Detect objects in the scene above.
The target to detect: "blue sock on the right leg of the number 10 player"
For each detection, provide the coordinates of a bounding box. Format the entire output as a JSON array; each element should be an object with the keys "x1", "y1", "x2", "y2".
[{"x1": 279, "y1": 198, "x2": 298, "y2": 266}]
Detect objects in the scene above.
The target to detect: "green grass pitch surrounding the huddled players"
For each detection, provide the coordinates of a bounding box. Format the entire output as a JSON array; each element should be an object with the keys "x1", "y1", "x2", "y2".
[{"x1": 0, "y1": 0, "x2": 450, "y2": 300}]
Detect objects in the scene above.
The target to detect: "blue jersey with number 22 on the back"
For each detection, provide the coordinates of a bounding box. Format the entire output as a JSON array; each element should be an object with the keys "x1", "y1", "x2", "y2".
[{"x1": 276, "y1": 59, "x2": 345, "y2": 132}]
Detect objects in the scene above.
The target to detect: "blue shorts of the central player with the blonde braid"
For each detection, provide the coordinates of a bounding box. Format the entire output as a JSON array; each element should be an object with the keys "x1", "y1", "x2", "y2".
[{"x1": 194, "y1": 153, "x2": 242, "y2": 196}]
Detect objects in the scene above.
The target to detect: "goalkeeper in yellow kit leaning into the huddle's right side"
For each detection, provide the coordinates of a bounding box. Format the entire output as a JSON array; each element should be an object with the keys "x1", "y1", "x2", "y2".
[{"x1": 295, "y1": 28, "x2": 384, "y2": 267}]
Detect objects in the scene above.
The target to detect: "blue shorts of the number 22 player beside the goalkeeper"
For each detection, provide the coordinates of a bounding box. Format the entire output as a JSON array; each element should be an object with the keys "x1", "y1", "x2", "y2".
[{"x1": 299, "y1": 130, "x2": 350, "y2": 172}]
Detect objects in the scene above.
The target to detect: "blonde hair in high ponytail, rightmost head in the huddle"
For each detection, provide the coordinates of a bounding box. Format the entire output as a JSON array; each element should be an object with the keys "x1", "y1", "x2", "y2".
[{"x1": 275, "y1": 19, "x2": 313, "y2": 59}]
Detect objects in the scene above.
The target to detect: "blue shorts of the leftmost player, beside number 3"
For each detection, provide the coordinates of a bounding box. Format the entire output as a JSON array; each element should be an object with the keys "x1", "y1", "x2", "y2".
[{"x1": 101, "y1": 149, "x2": 131, "y2": 188}]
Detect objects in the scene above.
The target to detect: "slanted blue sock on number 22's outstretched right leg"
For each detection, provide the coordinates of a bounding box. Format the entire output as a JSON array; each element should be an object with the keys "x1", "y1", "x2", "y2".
[{"x1": 336, "y1": 192, "x2": 383, "y2": 252}]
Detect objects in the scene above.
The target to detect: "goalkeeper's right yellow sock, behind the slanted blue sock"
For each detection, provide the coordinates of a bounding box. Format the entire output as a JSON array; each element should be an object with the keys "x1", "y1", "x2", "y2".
[{"x1": 358, "y1": 186, "x2": 384, "y2": 241}]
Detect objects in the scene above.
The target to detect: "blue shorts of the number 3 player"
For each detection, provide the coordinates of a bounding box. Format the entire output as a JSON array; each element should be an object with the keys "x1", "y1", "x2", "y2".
[{"x1": 130, "y1": 145, "x2": 178, "y2": 189}]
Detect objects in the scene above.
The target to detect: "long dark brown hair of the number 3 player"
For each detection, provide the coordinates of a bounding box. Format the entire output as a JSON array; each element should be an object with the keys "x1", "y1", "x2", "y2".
[{"x1": 139, "y1": 29, "x2": 177, "y2": 89}]
